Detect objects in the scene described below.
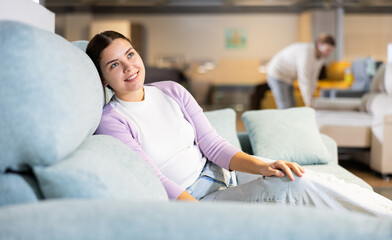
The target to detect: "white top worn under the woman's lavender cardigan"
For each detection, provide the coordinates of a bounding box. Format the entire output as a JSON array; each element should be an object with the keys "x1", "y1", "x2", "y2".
[{"x1": 110, "y1": 86, "x2": 206, "y2": 189}]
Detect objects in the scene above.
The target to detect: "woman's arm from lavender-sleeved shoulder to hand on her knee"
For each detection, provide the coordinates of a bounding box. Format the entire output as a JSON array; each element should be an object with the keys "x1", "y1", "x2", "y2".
[{"x1": 167, "y1": 81, "x2": 305, "y2": 180}]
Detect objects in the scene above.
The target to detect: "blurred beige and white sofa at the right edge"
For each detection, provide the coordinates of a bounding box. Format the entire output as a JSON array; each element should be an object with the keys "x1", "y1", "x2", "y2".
[{"x1": 314, "y1": 63, "x2": 392, "y2": 175}]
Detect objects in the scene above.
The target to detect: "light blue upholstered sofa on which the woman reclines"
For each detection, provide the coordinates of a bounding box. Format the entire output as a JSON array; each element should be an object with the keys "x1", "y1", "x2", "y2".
[{"x1": 0, "y1": 21, "x2": 392, "y2": 240}]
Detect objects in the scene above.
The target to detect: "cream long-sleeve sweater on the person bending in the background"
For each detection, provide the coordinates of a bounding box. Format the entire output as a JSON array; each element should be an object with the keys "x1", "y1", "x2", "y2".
[{"x1": 267, "y1": 43, "x2": 324, "y2": 106}]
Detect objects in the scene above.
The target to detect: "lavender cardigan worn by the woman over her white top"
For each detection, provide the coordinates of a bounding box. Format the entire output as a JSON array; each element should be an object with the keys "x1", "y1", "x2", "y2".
[{"x1": 95, "y1": 81, "x2": 240, "y2": 199}]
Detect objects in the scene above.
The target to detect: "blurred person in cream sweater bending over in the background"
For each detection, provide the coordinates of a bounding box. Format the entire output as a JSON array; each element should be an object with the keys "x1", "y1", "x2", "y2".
[{"x1": 267, "y1": 34, "x2": 335, "y2": 109}]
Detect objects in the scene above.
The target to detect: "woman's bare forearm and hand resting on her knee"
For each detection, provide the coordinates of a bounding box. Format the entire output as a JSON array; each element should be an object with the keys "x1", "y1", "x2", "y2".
[{"x1": 229, "y1": 152, "x2": 305, "y2": 180}]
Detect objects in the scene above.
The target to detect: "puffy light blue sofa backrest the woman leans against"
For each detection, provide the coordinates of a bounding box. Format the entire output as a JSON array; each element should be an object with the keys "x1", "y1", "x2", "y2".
[{"x1": 0, "y1": 21, "x2": 171, "y2": 206}]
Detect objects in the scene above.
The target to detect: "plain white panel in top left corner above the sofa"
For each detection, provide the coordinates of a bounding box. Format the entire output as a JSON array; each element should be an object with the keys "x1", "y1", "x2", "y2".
[{"x1": 0, "y1": 0, "x2": 55, "y2": 32}]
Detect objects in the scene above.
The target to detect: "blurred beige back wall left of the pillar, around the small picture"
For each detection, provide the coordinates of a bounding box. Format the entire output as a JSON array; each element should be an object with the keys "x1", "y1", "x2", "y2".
[{"x1": 57, "y1": 14, "x2": 298, "y2": 64}]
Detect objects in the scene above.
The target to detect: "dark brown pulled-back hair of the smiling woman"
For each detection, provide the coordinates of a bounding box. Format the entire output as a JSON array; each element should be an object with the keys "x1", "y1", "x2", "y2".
[{"x1": 86, "y1": 31, "x2": 131, "y2": 80}]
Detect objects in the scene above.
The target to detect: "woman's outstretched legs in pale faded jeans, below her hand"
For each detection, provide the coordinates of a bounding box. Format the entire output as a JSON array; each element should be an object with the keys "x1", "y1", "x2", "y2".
[{"x1": 202, "y1": 159, "x2": 392, "y2": 217}]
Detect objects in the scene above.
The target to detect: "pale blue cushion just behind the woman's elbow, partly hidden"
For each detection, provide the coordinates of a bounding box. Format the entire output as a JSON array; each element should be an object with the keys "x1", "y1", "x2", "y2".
[{"x1": 205, "y1": 108, "x2": 241, "y2": 149}]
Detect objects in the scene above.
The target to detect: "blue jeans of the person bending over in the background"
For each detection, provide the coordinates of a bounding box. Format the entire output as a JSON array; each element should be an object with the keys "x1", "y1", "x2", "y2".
[{"x1": 267, "y1": 75, "x2": 295, "y2": 109}]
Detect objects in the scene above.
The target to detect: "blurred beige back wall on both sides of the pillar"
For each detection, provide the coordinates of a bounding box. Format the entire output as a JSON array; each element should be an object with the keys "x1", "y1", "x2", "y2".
[{"x1": 56, "y1": 11, "x2": 392, "y2": 64}]
